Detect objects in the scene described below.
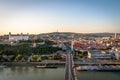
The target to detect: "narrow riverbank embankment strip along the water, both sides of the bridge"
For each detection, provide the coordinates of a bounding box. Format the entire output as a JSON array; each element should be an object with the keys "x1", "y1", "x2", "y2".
[{"x1": 0, "y1": 60, "x2": 120, "y2": 66}]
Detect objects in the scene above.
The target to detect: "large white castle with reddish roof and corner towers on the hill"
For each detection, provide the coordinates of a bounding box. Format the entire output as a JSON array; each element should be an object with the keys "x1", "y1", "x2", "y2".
[{"x1": 9, "y1": 32, "x2": 29, "y2": 41}]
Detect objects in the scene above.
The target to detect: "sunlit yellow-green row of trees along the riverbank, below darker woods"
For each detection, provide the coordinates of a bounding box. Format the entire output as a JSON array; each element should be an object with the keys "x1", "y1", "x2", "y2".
[{"x1": 0, "y1": 54, "x2": 62, "y2": 62}]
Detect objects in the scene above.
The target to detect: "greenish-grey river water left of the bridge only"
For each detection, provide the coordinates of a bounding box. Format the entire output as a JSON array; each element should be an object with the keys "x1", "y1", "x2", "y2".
[{"x1": 0, "y1": 67, "x2": 65, "y2": 80}]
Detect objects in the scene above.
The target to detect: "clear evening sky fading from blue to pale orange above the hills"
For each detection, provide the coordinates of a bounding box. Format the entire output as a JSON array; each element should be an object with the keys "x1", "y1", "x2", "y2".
[{"x1": 0, "y1": 0, "x2": 120, "y2": 35}]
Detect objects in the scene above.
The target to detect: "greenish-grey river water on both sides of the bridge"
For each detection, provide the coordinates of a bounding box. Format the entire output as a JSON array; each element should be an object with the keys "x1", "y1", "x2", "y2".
[{"x1": 0, "y1": 67, "x2": 120, "y2": 80}]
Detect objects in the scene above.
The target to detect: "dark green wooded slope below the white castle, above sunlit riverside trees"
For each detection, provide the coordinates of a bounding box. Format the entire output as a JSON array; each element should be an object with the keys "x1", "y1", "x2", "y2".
[{"x1": 0, "y1": 44, "x2": 62, "y2": 56}]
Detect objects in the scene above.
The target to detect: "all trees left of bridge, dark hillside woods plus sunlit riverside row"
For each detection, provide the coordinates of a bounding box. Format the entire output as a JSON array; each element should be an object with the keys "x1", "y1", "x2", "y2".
[{"x1": 0, "y1": 43, "x2": 62, "y2": 61}]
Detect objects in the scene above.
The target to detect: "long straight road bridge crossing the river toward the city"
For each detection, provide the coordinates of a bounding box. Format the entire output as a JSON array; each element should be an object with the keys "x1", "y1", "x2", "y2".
[{"x1": 65, "y1": 42, "x2": 77, "y2": 80}]
